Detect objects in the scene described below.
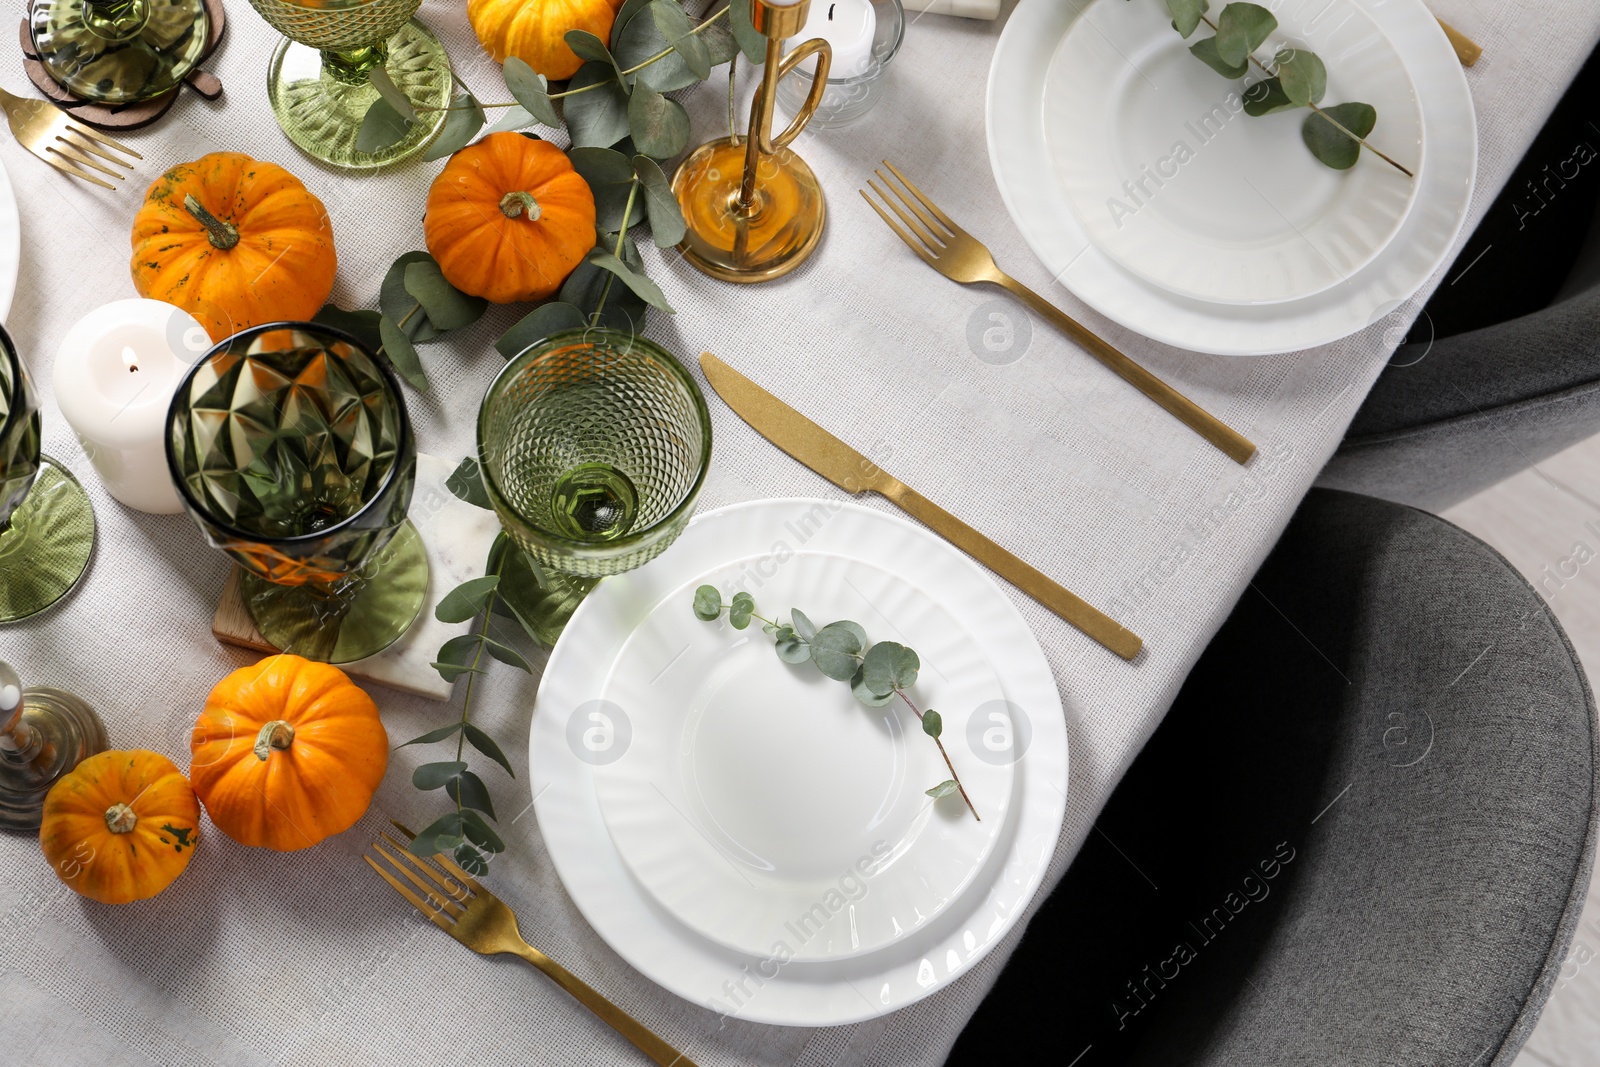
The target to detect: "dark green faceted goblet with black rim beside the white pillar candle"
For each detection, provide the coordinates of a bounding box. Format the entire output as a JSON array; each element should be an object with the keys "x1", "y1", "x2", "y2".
[{"x1": 166, "y1": 323, "x2": 429, "y2": 664}]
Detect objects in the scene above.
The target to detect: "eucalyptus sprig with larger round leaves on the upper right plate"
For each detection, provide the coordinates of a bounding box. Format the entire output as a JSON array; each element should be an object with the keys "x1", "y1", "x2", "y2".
[{"x1": 1165, "y1": 0, "x2": 1414, "y2": 178}]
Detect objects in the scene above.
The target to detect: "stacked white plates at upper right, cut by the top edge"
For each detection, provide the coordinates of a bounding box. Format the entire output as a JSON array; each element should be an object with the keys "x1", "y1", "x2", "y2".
[{"x1": 989, "y1": 0, "x2": 1477, "y2": 355}]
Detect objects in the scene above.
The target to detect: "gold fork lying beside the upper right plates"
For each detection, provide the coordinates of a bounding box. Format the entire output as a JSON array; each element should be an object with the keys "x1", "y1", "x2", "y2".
[{"x1": 861, "y1": 160, "x2": 1256, "y2": 464}]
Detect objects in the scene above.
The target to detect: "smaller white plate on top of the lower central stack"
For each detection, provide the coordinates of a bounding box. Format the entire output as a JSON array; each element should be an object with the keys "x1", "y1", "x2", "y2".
[{"x1": 595, "y1": 552, "x2": 1013, "y2": 960}]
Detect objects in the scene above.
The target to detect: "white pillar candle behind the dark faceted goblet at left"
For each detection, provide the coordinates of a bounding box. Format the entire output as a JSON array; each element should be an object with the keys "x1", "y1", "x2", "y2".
[{"x1": 54, "y1": 301, "x2": 211, "y2": 515}]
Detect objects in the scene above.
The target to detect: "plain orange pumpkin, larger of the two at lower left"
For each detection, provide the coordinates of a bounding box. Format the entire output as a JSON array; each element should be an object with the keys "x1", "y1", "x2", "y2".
[{"x1": 189, "y1": 656, "x2": 389, "y2": 853}]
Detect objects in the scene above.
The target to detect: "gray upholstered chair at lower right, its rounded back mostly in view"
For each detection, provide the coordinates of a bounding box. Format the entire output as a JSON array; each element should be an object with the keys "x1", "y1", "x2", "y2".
[{"x1": 949, "y1": 490, "x2": 1600, "y2": 1067}]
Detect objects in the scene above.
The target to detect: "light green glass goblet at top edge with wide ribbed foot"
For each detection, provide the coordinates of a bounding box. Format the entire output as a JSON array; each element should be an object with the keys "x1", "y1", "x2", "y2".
[{"x1": 250, "y1": 0, "x2": 451, "y2": 170}]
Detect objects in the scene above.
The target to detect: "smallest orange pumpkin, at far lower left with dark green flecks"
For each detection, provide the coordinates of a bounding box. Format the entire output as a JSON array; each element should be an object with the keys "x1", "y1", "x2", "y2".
[{"x1": 38, "y1": 750, "x2": 200, "y2": 904}]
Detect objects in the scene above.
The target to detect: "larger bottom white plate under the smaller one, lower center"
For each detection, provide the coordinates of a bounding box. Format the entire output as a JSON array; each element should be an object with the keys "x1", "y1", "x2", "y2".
[{"x1": 530, "y1": 499, "x2": 1067, "y2": 1025}]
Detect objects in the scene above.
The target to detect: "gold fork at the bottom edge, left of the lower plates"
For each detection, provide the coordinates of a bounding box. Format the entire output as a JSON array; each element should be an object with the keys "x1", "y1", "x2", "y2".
[{"x1": 362, "y1": 822, "x2": 694, "y2": 1067}]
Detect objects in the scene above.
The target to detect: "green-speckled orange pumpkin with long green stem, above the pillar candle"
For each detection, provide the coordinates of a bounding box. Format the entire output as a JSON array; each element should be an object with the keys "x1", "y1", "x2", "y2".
[{"x1": 133, "y1": 152, "x2": 338, "y2": 341}]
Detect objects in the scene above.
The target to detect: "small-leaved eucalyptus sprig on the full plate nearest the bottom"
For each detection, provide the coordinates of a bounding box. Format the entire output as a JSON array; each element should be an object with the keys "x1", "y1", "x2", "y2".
[{"x1": 694, "y1": 585, "x2": 982, "y2": 822}]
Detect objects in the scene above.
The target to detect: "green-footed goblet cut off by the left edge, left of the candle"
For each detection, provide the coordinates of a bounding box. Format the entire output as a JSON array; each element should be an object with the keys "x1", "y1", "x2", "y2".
[{"x1": 0, "y1": 321, "x2": 94, "y2": 622}]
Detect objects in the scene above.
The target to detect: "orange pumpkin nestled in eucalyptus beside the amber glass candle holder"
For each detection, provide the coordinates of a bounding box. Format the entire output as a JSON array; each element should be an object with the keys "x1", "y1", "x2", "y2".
[{"x1": 424, "y1": 133, "x2": 595, "y2": 304}]
